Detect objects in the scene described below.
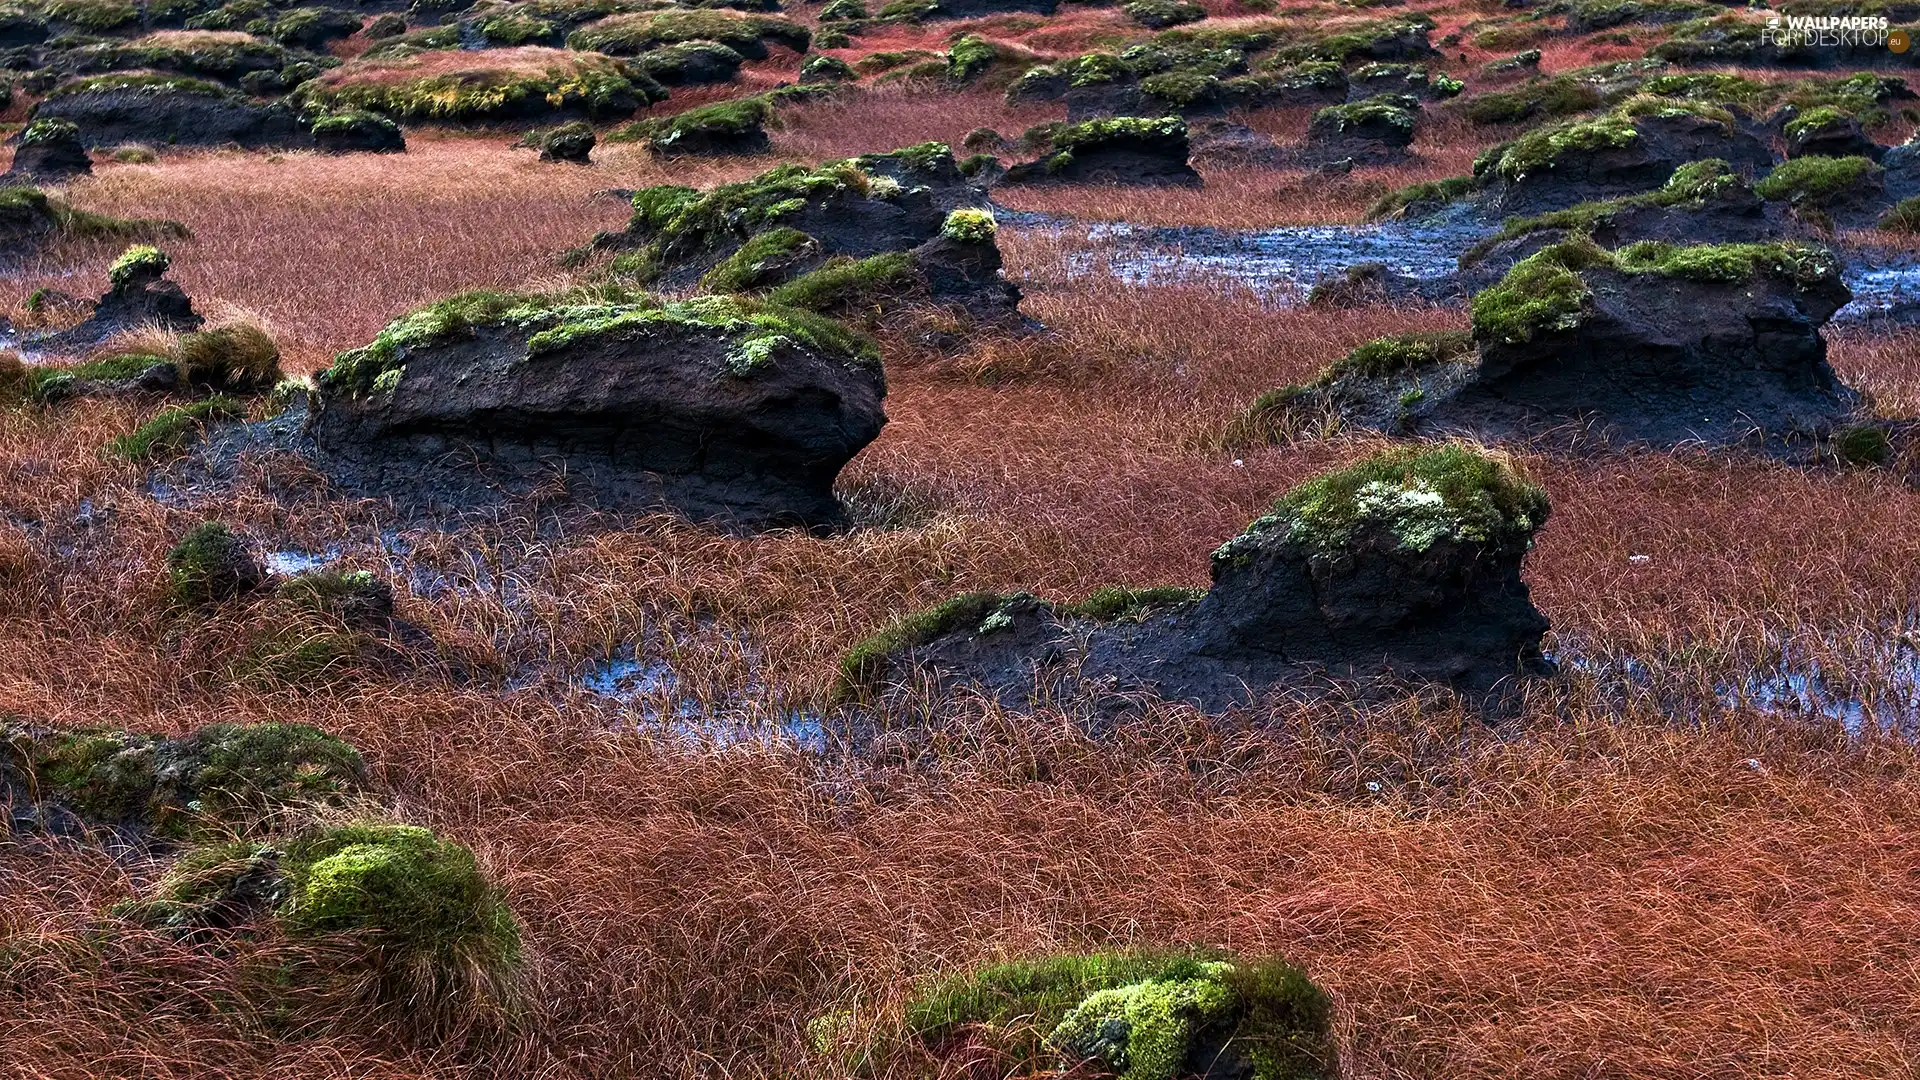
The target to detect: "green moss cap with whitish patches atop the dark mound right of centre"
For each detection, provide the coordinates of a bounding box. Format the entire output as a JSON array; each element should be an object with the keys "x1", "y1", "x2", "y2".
[{"x1": 1213, "y1": 444, "x2": 1548, "y2": 553}]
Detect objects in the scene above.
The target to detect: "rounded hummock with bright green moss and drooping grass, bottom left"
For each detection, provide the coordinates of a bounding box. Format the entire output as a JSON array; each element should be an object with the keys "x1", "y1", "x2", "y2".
[{"x1": 115, "y1": 822, "x2": 526, "y2": 1038}]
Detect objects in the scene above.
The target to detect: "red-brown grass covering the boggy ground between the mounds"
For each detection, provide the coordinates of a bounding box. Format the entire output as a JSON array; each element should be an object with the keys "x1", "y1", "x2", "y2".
[{"x1": 0, "y1": 2, "x2": 1920, "y2": 1080}]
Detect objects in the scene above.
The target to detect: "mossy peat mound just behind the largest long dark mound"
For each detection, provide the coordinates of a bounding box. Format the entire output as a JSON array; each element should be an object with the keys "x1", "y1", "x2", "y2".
[{"x1": 593, "y1": 142, "x2": 1020, "y2": 319}]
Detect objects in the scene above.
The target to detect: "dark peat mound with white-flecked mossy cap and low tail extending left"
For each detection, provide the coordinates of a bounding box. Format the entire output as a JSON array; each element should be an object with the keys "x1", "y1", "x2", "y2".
[{"x1": 839, "y1": 446, "x2": 1549, "y2": 711}]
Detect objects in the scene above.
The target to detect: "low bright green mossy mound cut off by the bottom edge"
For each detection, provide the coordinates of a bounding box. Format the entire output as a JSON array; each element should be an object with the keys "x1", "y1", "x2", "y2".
[{"x1": 875, "y1": 951, "x2": 1338, "y2": 1080}]
